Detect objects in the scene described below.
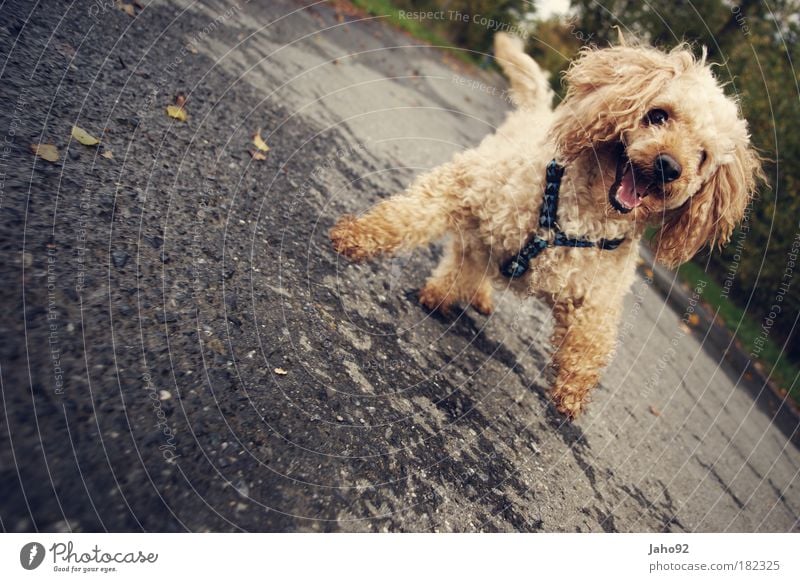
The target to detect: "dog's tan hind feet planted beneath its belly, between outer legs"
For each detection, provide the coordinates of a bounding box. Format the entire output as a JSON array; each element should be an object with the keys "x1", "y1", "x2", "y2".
[{"x1": 419, "y1": 239, "x2": 493, "y2": 315}]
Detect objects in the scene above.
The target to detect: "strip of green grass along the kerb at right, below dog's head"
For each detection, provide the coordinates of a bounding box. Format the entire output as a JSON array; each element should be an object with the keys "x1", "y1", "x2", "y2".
[{"x1": 678, "y1": 262, "x2": 800, "y2": 403}]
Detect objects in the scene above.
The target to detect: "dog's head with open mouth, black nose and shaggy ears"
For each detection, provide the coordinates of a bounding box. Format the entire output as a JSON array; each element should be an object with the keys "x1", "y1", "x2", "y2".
[{"x1": 554, "y1": 46, "x2": 763, "y2": 265}]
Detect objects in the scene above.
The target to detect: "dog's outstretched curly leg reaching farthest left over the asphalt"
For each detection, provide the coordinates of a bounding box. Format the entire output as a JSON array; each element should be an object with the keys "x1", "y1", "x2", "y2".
[{"x1": 330, "y1": 161, "x2": 466, "y2": 261}]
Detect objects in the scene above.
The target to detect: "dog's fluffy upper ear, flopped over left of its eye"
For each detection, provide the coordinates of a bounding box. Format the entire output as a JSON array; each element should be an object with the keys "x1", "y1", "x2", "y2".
[{"x1": 553, "y1": 45, "x2": 694, "y2": 162}]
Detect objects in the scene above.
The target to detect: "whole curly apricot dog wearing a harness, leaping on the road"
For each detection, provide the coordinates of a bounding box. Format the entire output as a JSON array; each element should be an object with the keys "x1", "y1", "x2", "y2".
[{"x1": 330, "y1": 34, "x2": 763, "y2": 418}]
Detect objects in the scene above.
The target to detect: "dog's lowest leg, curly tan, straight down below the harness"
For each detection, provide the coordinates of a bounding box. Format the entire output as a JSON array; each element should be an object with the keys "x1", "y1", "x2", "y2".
[{"x1": 552, "y1": 299, "x2": 621, "y2": 419}]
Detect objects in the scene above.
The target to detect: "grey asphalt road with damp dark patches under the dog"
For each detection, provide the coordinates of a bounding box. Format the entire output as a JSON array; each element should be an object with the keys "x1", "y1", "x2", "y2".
[{"x1": 0, "y1": 0, "x2": 800, "y2": 532}]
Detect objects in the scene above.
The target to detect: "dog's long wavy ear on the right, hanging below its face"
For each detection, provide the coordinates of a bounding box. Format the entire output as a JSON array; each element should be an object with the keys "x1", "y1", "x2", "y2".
[{"x1": 655, "y1": 143, "x2": 766, "y2": 267}]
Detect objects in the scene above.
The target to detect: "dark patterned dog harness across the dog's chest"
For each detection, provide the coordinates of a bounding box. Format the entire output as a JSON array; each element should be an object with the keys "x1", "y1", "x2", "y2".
[{"x1": 500, "y1": 160, "x2": 625, "y2": 279}]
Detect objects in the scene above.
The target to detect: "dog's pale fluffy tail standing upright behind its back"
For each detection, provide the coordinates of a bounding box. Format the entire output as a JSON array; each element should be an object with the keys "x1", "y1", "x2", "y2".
[{"x1": 494, "y1": 32, "x2": 553, "y2": 109}]
